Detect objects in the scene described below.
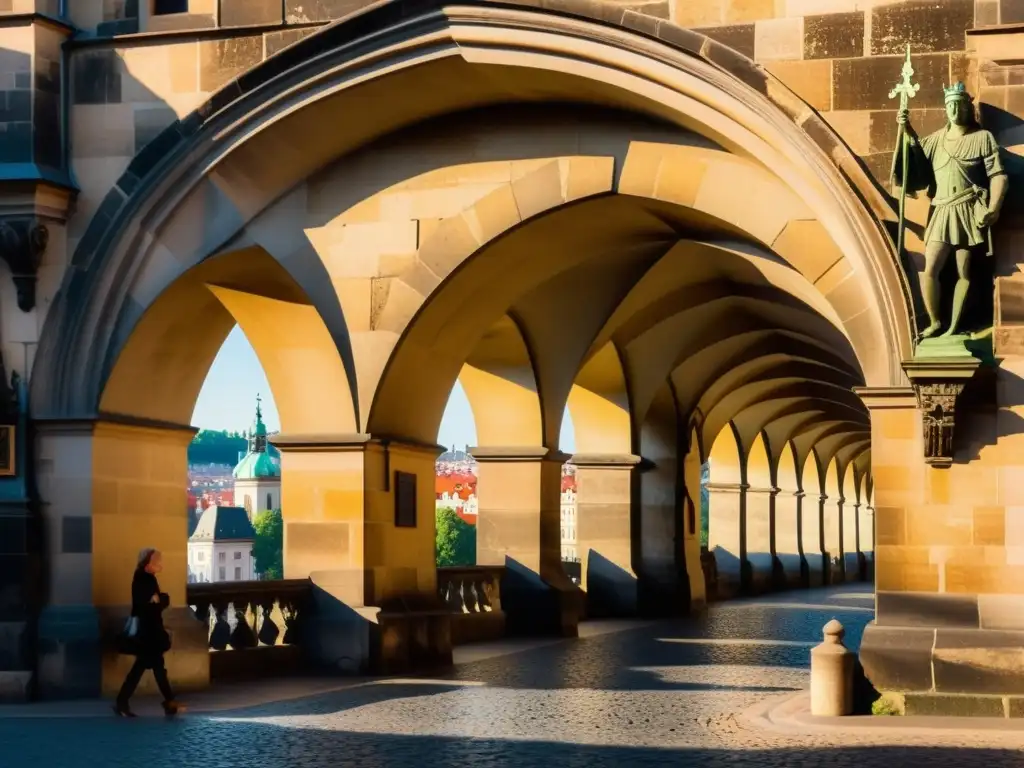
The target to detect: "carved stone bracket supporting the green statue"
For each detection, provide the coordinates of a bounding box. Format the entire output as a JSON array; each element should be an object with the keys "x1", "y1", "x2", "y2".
[{"x1": 903, "y1": 357, "x2": 981, "y2": 467}]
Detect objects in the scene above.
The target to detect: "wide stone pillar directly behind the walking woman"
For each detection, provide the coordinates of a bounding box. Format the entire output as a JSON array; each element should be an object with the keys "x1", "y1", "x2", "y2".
[{"x1": 36, "y1": 417, "x2": 210, "y2": 698}]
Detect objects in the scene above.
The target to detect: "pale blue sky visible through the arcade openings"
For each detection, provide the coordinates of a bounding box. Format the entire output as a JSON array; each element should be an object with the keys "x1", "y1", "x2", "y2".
[{"x1": 191, "y1": 326, "x2": 575, "y2": 453}]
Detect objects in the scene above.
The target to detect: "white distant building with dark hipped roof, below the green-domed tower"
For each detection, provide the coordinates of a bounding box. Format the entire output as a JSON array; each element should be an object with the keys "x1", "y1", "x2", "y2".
[{"x1": 188, "y1": 507, "x2": 256, "y2": 584}]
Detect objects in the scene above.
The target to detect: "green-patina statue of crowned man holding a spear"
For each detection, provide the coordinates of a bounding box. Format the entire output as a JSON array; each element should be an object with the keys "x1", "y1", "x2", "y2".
[{"x1": 893, "y1": 80, "x2": 1008, "y2": 339}]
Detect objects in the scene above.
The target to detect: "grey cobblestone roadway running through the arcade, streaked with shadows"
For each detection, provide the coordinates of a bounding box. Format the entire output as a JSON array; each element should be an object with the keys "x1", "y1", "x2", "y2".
[{"x1": 0, "y1": 585, "x2": 1024, "y2": 768}]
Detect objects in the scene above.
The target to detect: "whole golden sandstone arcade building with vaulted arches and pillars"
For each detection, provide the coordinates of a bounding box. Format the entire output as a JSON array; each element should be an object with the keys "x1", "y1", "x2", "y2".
[{"x1": 0, "y1": 0, "x2": 1024, "y2": 714}]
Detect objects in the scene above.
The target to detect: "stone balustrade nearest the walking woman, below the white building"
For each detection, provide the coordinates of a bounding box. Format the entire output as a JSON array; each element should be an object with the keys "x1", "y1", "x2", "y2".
[{"x1": 187, "y1": 579, "x2": 312, "y2": 678}]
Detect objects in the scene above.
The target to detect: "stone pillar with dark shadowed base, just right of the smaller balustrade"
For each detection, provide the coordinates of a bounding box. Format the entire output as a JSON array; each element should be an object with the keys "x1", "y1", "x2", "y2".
[{"x1": 470, "y1": 446, "x2": 585, "y2": 637}]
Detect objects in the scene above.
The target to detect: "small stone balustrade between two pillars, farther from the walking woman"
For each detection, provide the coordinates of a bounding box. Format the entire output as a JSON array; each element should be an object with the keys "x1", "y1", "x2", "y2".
[{"x1": 437, "y1": 565, "x2": 505, "y2": 645}]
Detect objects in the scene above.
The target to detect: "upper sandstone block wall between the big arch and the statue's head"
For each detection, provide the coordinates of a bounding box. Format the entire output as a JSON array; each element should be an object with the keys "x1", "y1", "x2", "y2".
[{"x1": 670, "y1": 0, "x2": 1024, "y2": 186}]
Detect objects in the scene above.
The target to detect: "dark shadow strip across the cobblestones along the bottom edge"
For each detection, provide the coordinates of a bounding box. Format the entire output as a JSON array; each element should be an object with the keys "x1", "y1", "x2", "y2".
[{"x1": 3, "y1": 720, "x2": 1021, "y2": 768}]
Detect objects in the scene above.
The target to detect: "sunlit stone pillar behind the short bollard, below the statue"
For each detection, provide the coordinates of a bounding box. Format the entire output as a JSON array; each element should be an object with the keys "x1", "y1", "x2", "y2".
[{"x1": 860, "y1": 380, "x2": 1024, "y2": 717}]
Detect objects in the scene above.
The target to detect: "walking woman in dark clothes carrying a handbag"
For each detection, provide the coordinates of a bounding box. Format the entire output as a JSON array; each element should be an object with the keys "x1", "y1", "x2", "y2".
[{"x1": 114, "y1": 549, "x2": 185, "y2": 718}]
